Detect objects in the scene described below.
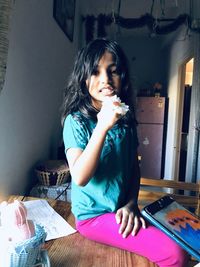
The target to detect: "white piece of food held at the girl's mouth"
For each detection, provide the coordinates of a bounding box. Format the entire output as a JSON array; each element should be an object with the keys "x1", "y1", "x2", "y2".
[{"x1": 104, "y1": 95, "x2": 129, "y2": 116}]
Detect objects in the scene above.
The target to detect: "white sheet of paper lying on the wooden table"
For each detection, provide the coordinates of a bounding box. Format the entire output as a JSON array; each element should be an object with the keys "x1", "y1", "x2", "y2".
[{"x1": 23, "y1": 199, "x2": 76, "y2": 241}]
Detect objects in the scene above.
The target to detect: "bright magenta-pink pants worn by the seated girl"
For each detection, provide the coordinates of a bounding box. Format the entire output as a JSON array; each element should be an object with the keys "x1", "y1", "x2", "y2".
[{"x1": 76, "y1": 213, "x2": 188, "y2": 267}]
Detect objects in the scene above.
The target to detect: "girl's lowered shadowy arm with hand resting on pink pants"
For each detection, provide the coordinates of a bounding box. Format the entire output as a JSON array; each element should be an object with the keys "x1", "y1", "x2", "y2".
[{"x1": 116, "y1": 152, "x2": 146, "y2": 238}]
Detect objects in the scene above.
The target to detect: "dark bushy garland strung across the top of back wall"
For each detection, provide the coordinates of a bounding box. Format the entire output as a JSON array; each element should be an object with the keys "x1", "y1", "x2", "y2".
[{"x1": 84, "y1": 13, "x2": 192, "y2": 42}]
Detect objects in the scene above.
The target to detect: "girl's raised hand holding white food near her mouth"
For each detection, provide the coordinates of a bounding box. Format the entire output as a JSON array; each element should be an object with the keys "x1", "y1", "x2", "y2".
[{"x1": 97, "y1": 99, "x2": 122, "y2": 131}]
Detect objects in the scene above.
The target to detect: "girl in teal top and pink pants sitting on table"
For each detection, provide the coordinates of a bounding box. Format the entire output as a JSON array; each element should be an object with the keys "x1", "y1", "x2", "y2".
[{"x1": 62, "y1": 39, "x2": 186, "y2": 267}]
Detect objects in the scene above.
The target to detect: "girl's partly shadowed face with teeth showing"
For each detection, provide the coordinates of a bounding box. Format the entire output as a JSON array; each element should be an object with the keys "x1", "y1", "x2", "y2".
[{"x1": 86, "y1": 52, "x2": 121, "y2": 110}]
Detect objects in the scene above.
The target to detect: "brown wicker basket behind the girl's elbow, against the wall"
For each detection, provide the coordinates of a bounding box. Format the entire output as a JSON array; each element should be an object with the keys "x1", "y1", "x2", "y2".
[{"x1": 35, "y1": 160, "x2": 70, "y2": 186}]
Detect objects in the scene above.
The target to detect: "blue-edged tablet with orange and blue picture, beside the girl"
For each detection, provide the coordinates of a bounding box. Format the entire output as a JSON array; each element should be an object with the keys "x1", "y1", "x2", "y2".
[{"x1": 141, "y1": 196, "x2": 200, "y2": 261}]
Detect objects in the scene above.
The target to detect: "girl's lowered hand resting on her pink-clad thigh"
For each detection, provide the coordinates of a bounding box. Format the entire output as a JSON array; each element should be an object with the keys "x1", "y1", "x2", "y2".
[{"x1": 115, "y1": 206, "x2": 146, "y2": 238}]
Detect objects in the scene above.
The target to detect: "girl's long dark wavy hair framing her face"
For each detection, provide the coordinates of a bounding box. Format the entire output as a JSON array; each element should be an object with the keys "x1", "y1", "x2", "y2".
[{"x1": 62, "y1": 39, "x2": 133, "y2": 124}]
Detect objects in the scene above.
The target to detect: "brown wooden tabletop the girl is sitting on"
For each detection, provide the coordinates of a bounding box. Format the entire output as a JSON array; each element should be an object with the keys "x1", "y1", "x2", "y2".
[{"x1": 0, "y1": 196, "x2": 159, "y2": 267}]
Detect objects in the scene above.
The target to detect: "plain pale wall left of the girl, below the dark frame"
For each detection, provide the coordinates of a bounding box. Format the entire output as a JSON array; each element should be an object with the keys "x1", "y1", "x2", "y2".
[{"x1": 0, "y1": 0, "x2": 78, "y2": 197}]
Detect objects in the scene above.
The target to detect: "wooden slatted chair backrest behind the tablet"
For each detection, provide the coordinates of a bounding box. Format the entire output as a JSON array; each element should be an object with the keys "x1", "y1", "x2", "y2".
[{"x1": 138, "y1": 177, "x2": 200, "y2": 216}]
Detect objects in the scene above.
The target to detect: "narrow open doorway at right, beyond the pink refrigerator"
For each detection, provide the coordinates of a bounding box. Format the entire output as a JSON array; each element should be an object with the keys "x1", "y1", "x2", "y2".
[{"x1": 175, "y1": 58, "x2": 194, "y2": 181}]
